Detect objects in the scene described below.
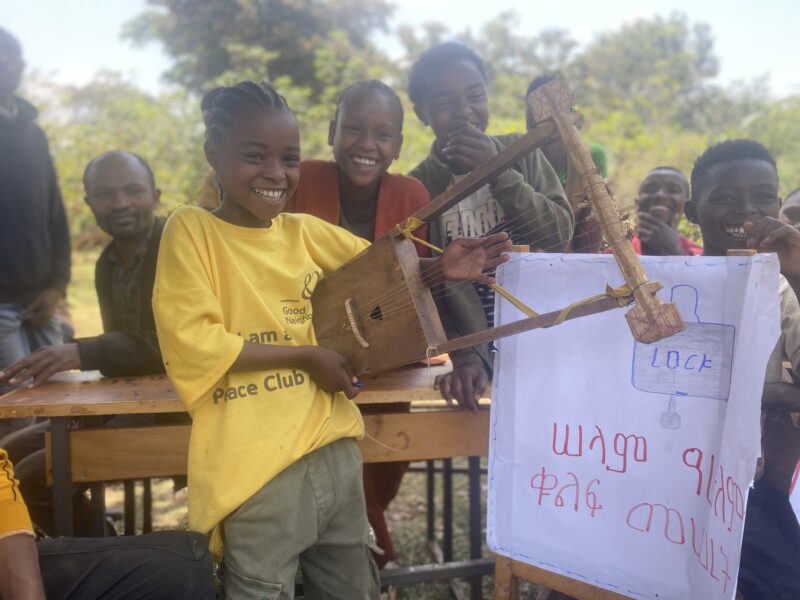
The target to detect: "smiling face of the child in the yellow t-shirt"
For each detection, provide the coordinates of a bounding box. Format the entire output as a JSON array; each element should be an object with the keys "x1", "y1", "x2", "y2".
[{"x1": 206, "y1": 107, "x2": 300, "y2": 227}]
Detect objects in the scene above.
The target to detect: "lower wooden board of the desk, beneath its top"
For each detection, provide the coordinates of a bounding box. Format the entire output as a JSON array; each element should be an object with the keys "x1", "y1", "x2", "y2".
[{"x1": 54, "y1": 409, "x2": 489, "y2": 483}]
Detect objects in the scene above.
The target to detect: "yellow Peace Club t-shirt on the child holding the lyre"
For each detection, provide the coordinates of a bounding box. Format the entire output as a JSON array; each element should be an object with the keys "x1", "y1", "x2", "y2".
[{"x1": 153, "y1": 207, "x2": 369, "y2": 545}]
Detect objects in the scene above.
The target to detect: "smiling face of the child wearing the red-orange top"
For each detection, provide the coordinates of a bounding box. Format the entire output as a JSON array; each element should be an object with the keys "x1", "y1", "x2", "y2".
[{"x1": 328, "y1": 89, "x2": 403, "y2": 188}]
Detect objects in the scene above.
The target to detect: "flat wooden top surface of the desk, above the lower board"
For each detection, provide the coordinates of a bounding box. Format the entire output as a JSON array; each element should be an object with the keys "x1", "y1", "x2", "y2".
[{"x1": 0, "y1": 365, "x2": 488, "y2": 419}]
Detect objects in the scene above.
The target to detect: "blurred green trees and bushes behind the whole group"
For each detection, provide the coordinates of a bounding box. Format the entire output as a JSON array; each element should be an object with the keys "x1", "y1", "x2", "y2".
[{"x1": 23, "y1": 0, "x2": 800, "y2": 248}]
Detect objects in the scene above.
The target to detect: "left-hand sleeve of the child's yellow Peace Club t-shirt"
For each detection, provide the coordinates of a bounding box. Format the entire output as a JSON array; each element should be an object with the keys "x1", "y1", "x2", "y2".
[{"x1": 153, "y1": 211, "x2": 244, "y2": 410}]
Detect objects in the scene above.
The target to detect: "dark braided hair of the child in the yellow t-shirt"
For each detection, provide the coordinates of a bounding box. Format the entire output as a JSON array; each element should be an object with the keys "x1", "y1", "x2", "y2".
[{"x1": 200, "y1": 81, "x2": 292, "y2": 144}]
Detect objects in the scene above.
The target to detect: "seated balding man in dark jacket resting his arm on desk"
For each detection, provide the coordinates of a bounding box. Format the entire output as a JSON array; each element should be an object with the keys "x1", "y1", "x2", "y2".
[{"x1": 0, "y1": 151, "x2": 169, "y2": 532}]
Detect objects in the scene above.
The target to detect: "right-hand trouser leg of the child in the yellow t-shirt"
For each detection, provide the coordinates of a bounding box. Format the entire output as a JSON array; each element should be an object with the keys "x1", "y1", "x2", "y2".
[{"x1": 300, "y1": 438, "x2": 380, "y2": 600}]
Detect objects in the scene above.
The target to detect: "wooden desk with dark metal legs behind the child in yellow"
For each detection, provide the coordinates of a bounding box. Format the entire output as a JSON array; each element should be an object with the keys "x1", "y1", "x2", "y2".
[{"x1": 0, "y1": 366, "x2": 491, "y2": 597}]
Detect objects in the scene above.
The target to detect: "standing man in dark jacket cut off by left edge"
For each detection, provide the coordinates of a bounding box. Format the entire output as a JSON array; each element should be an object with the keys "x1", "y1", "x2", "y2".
[{"x1": 0, "y1": 29, "x2": 70, "y2": 435}]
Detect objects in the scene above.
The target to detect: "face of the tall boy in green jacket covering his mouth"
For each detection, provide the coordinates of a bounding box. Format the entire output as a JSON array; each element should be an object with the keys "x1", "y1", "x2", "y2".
[{"x1": 414, "y1": 60, "x2": 489, "y2": 146}]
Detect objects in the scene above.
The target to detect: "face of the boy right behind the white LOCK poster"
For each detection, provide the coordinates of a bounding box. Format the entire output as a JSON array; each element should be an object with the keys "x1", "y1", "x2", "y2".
[{"x1": 686, "y1": 159, "x2": 780, "y2": 256}]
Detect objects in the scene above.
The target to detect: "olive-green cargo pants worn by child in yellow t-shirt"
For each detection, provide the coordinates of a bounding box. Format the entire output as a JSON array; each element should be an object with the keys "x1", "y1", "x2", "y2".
[{"x1": 222, "y1": 438, "x2": 380, "y2": 600}]
